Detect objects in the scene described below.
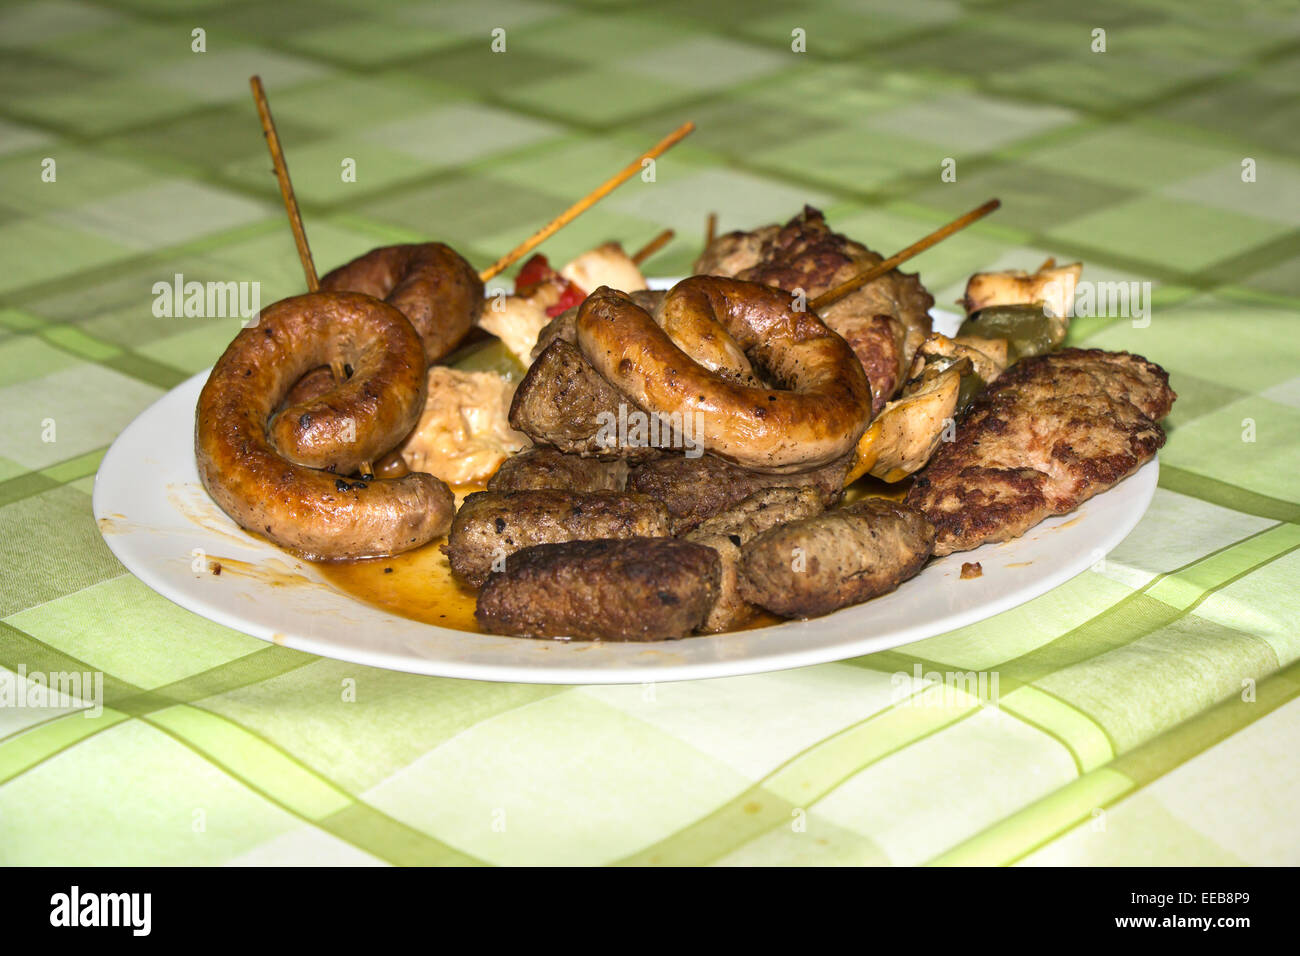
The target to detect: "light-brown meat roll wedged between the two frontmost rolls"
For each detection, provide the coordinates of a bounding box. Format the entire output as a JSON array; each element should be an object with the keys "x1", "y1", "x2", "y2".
[{"x1": 686, "y1": 488, "x2": 826, "y2": 633}]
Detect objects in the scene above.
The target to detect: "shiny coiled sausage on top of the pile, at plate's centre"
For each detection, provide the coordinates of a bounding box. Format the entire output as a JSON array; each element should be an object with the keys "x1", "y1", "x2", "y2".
[{"x1": 576, "y1": 276, "x2": 871, "y2": 472}]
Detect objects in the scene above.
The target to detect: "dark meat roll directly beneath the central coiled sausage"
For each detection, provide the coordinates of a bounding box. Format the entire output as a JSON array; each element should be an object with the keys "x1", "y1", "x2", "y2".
[{"x1": 628, "y1": 455, "x2": 848, "y2": 535}]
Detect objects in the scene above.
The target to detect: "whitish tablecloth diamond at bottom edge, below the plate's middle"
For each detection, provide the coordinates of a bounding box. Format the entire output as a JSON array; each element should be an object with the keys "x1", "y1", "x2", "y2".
[{"x1": 363, "y1": 692, "x2": 750, "y2": 865}]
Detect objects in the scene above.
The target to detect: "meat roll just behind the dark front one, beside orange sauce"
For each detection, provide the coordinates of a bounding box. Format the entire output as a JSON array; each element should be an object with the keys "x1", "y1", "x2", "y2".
[{"x1": 442, "y1": 490, "x2": 668, "y2": 587}]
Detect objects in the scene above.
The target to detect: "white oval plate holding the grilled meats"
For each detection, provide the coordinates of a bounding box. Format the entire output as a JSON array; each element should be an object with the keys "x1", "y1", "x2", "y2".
[{"x1": 94, "y1": 303, "x2": 1160, "y2": 684}]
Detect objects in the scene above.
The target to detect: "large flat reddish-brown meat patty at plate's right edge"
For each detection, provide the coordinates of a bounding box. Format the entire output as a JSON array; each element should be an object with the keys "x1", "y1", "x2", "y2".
[{"x1": 907, "y1": 349, "x2": 1177, "y2": 554}]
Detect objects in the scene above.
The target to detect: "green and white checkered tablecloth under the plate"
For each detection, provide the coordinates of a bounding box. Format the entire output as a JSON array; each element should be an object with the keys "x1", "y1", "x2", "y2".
[{"x1": 0, "y1": 0, "x2": 1300, "y2": 864}]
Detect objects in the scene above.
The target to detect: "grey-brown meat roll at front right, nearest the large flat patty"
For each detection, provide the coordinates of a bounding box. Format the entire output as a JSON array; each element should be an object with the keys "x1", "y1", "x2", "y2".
[{"x1": 740, "y1": 498, "x2": 935, "y2": 618}]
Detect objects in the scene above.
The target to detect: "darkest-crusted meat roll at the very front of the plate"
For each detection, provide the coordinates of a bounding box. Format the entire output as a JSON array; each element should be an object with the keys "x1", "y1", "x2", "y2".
[{"x1": 475, "y1": 537, "x2": 720, "y2": 641}]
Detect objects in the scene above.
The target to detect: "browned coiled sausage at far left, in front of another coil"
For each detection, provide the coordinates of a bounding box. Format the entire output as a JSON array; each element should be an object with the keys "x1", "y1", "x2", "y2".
[{"x1": 194, "y1": 293, "x2": 454, "y2": 559}]
